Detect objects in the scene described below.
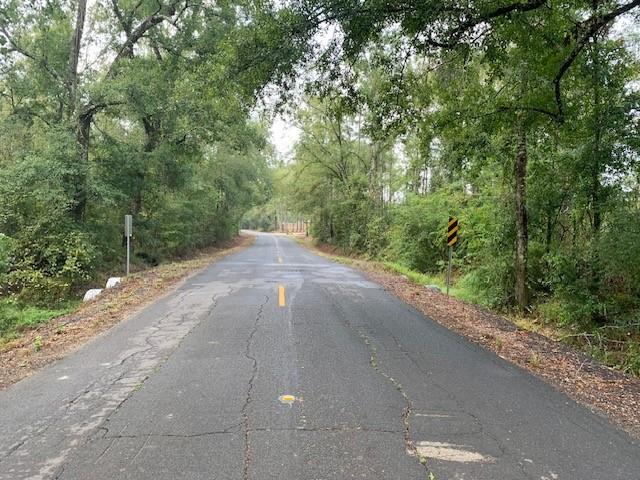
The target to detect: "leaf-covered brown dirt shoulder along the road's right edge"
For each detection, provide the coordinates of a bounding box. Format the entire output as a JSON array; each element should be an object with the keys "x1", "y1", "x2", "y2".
[{"x1": 301, "y1": 241, "x2": 640, "y2": 438}]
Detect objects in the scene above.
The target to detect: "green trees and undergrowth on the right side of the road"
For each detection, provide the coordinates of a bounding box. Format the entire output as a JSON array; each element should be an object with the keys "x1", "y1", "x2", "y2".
[{"x1": 258, "y1": 11, "x2": 640, "y2": 371}]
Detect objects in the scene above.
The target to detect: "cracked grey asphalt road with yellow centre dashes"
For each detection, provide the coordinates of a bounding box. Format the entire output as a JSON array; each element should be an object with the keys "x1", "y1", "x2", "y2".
[{"x1": 0, "y1": 234, "x2": 640, "y2": 480}]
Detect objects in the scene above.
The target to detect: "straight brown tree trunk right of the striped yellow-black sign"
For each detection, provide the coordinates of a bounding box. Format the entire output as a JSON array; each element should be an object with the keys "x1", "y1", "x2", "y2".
[{"x1": 515, "y1": 125, "x2": 529, "y2": 310}]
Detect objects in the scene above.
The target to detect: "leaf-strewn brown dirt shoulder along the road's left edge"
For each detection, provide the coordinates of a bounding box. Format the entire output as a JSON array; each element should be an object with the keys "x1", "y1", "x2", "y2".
[{"x1": 0, "y1": 235, "x2": 255, "y2": 389}]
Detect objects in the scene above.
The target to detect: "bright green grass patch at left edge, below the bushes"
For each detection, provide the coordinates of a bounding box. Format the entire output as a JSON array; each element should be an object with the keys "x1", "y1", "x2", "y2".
[{"x1": 0, "y1": 298, "x2": 80, "y2": 345}]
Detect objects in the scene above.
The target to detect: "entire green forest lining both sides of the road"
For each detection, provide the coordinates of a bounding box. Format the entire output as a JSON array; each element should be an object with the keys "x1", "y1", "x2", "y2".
[{"x1": 0, "y1": 0, "x2": 640, "y2": 374}]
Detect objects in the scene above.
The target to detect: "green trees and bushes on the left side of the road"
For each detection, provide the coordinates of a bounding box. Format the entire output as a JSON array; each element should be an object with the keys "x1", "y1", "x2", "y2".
[{"x1": 0, "y1": 1, "x2": 274, "y2": 306}]
